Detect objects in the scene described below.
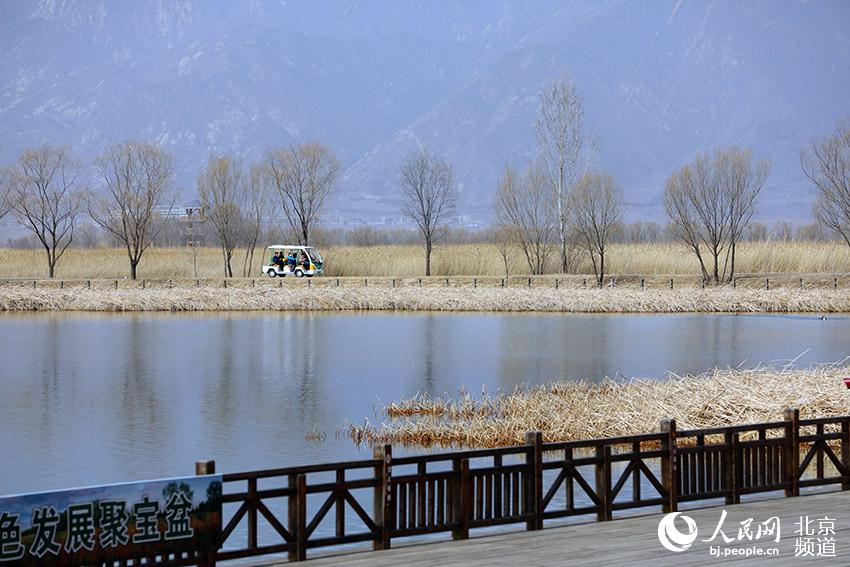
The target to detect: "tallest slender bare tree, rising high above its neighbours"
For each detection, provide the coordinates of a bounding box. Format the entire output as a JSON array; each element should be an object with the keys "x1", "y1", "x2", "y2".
[{"x1": 537, "y1": 78, "x2": 587, "y2": 273}]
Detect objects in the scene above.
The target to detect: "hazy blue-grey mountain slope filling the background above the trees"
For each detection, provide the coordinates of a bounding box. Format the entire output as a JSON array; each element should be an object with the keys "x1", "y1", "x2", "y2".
[{"x1": 0, "y1": 0, "x2": 850, "y2": 220}]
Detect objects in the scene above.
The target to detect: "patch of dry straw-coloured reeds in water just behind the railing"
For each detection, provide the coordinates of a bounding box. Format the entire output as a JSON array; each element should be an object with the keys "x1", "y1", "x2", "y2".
[{"x1": 349, "y1": 365, "x2": 850, "y2": 447}]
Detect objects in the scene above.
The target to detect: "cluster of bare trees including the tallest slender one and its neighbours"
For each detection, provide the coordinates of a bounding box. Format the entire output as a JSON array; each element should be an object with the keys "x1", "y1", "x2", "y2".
[{"x1": 496, "y1": 79, "x2": 624, "y2": 284}]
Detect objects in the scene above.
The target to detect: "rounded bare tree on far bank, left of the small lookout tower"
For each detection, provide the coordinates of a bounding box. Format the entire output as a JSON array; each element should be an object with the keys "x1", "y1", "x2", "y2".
[{"x1": 88, "y1": 142, "x2": 176, "y2": 279}]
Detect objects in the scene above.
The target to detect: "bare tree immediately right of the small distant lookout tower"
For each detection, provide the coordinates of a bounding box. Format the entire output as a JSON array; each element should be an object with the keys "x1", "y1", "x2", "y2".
[{"x1": 198, "y1": 155, "x2": 245, "y2": 278}]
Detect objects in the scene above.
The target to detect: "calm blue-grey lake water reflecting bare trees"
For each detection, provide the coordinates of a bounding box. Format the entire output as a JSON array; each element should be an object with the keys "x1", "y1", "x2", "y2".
[{"x1": 0, "y1": 313, "x2": 850, "y2": 494}]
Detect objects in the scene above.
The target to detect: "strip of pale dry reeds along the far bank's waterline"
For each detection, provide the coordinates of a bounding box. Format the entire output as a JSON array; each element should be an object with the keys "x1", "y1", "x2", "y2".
[{"x1": 0, "y1": 287, "x2": 850, "y2": 313}]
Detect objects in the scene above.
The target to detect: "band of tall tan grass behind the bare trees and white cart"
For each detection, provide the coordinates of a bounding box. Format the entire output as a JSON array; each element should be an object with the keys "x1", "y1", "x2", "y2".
[{"x1": 0, "y1": 242, "x2": 850, "y2": 279}]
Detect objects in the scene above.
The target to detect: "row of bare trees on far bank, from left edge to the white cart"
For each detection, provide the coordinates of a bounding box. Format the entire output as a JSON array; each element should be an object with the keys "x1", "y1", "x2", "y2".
[{"x1": 0, "y1": 142, "x2": 339, "y2": 279}]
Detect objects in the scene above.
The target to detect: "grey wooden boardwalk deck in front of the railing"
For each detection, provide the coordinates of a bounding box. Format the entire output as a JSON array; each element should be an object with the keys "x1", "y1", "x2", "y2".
[{"x1": 256, "y1": 491, "x2": 850, "y2": 567}]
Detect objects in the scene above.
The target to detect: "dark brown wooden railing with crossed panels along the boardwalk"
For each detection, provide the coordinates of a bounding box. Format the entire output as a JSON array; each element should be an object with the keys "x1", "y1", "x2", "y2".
[{"x1": 202, "y1": 410, "x2": 850, "y2": 561}]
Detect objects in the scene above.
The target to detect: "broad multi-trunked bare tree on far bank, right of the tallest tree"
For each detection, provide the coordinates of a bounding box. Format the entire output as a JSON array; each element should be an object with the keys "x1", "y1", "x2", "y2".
[{"x1": 664, "y1": 147, "x2": 770, "y2": 283}]
